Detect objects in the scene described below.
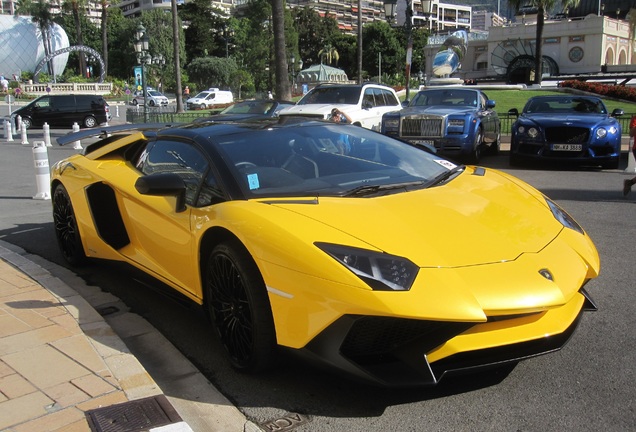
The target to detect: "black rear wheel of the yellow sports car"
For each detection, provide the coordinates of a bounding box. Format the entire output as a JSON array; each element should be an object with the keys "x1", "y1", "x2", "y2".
[{"x1": 52, "y1": 185, "x2": 86, "y2": 266}]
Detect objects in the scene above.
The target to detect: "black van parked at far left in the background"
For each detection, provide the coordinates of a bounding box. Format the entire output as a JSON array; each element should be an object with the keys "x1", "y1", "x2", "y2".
[{"x1": 11, "y1": 94, "x2": 111, "y2": 129}]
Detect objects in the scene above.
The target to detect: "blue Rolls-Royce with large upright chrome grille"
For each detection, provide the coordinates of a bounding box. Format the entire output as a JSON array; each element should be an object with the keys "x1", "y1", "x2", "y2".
[{"x1": 382, "y1": 87, "x2": 501, "y2": 164}]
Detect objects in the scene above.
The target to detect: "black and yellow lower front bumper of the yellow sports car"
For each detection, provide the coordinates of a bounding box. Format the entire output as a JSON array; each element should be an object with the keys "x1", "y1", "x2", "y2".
[{"x1": 301, "y1": 289, "x2": 596, "y2": 387}]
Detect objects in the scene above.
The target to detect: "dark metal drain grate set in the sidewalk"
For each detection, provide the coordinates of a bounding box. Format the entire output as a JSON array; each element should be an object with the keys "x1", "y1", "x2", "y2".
[{"x1": 86, "y1": 395, "x2": 181, "y2": 432}]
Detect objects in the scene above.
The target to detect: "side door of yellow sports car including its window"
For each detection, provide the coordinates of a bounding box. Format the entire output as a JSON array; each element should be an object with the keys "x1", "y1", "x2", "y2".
[{"x1": 125, "y1": 139, "x2": 220, "y2": 295}]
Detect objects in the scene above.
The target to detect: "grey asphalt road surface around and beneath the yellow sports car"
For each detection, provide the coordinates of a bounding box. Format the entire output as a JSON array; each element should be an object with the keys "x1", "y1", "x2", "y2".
[{"x1": 0, "y1": 103, "x2": 636, "y2": 432}]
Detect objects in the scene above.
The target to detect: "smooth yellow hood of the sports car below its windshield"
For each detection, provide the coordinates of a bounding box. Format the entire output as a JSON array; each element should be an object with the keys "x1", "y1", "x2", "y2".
[{"x1": 268, "y1": 169, "x2": 563, "y2": 268}]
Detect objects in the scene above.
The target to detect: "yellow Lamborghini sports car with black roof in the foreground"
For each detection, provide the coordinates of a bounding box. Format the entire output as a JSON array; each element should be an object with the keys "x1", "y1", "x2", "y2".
[{"x1": 51, "y1": 118, "x2": 600, "y2": 386}]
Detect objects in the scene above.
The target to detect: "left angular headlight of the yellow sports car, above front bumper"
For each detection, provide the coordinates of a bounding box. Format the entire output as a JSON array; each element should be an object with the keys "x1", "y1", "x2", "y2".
[{"x1": 316, "y1": 243, "x2": 418, "y2": 291}]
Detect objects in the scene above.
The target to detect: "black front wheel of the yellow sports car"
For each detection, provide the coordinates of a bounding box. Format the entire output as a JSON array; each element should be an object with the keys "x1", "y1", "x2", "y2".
[{"x1": 203, "y1": 241, "x2": 276, "y2": 373}]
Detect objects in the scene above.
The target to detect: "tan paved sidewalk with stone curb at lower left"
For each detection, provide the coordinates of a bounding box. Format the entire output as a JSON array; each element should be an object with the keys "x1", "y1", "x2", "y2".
[{"x1": 0, "y1": 241, "x2": 261, "y2": 432}]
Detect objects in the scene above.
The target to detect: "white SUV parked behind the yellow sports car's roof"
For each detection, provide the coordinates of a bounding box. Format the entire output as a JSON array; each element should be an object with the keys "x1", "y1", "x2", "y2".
[{"x1": 280, "y1": 83, "x2": 402, "y2": 131}]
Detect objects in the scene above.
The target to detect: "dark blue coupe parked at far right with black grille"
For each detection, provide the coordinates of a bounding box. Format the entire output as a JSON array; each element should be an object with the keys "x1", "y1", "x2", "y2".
[{"x1": 509, "y1": 94, "x2": 624, "y2": 169}]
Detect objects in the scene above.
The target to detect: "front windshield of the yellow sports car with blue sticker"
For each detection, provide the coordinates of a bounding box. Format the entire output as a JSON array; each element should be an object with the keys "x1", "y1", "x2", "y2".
[{"x1": 219, "y1": 124, "x2": 456, "y2": 197}]
